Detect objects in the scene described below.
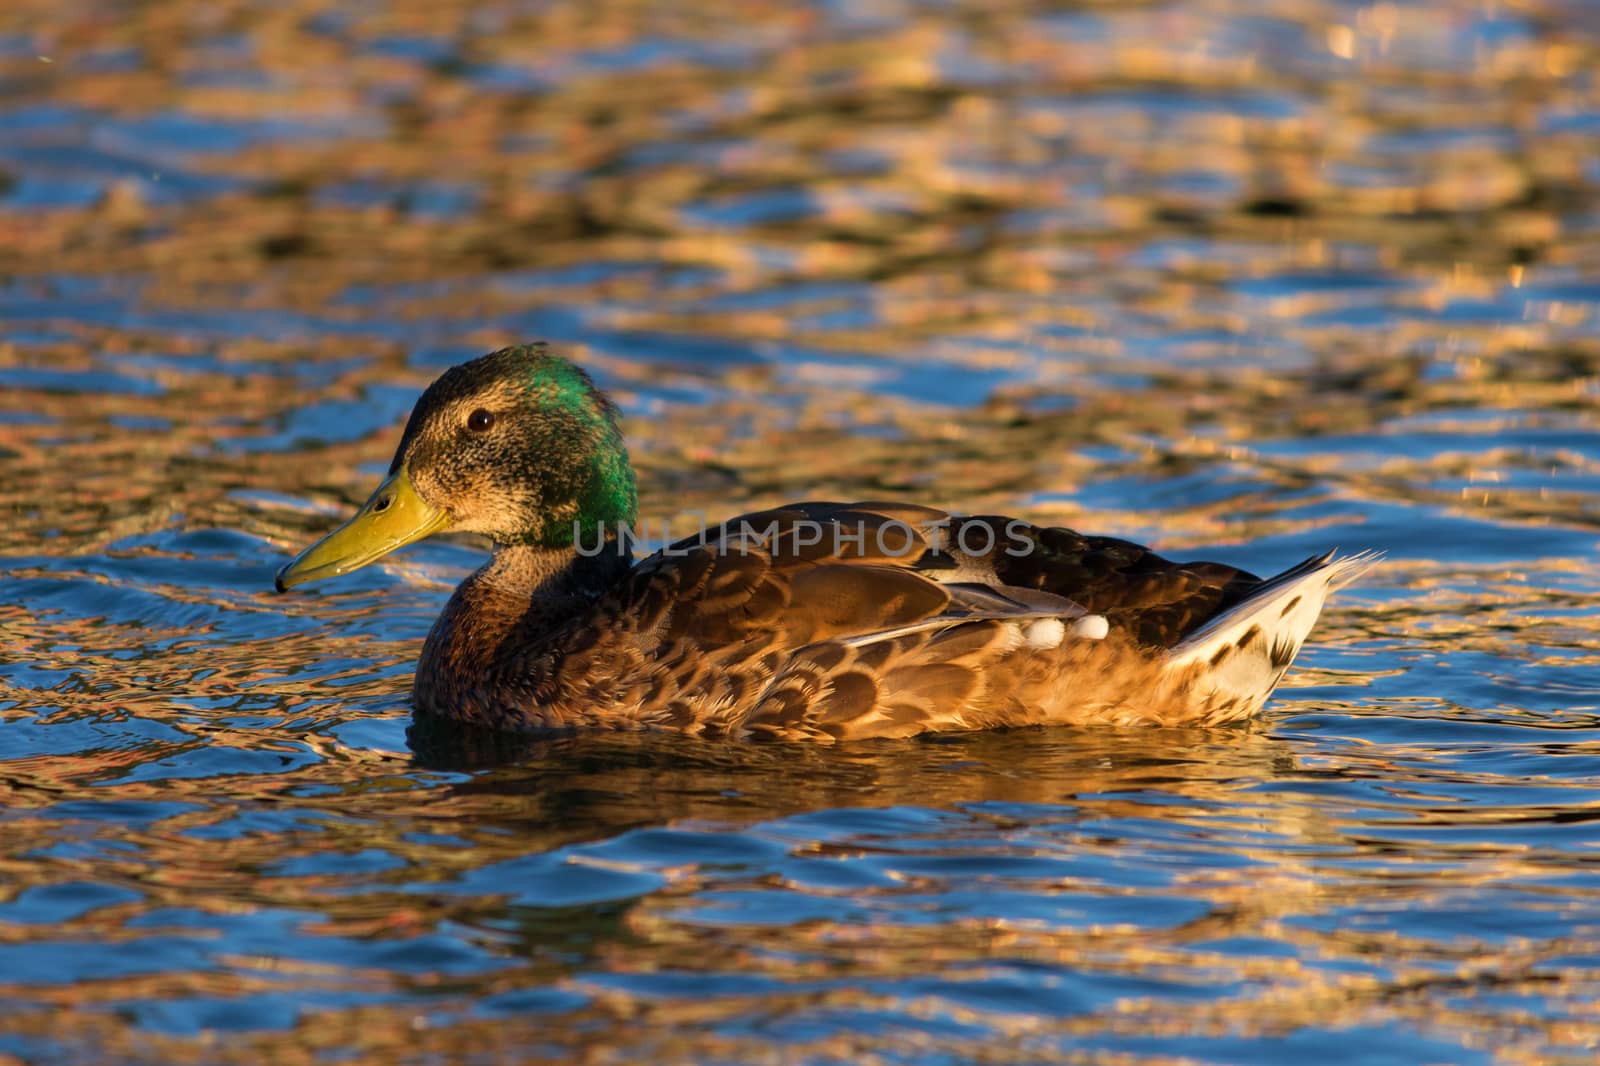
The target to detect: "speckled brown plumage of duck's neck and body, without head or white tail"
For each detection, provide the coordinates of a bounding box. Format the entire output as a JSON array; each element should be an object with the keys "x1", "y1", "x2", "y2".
[{"x1": 414, "y1": 503, "x2": 1363, "y2": 739}]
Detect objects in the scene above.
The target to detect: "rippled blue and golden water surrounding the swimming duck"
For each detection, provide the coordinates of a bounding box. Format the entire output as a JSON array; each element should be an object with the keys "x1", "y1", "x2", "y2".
[{"x1": 0, "y1": 0, "x2": 1600, "y2": 1064}]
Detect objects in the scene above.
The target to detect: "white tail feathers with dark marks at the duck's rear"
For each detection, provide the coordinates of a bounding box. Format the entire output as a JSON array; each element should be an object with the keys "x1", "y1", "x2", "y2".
[{"x1": 1168, "y1": 552, "x2": 1382, "y2": 711}]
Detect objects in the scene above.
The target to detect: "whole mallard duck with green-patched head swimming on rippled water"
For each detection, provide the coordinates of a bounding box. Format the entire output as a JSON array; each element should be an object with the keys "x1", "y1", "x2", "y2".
[{"x1": 277, "y1": 344, "x2": 1374, "y2": 741}]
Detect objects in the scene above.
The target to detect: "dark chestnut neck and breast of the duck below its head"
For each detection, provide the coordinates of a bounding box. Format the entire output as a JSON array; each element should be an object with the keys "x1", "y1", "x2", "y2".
[{"x1": 411, "y1": 541, "x2": 632, "y2": 723}]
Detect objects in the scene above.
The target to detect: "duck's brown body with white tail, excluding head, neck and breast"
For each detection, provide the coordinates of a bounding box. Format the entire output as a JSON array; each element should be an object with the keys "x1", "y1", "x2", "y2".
[{"x1": 418, "y1": 503, "x2": 1382, "y2": 739}]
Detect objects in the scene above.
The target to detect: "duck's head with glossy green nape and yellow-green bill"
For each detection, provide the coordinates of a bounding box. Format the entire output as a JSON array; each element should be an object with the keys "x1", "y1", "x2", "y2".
[{"x1": 277, "y1": 344, "x2": 637, "y2": 592}]
